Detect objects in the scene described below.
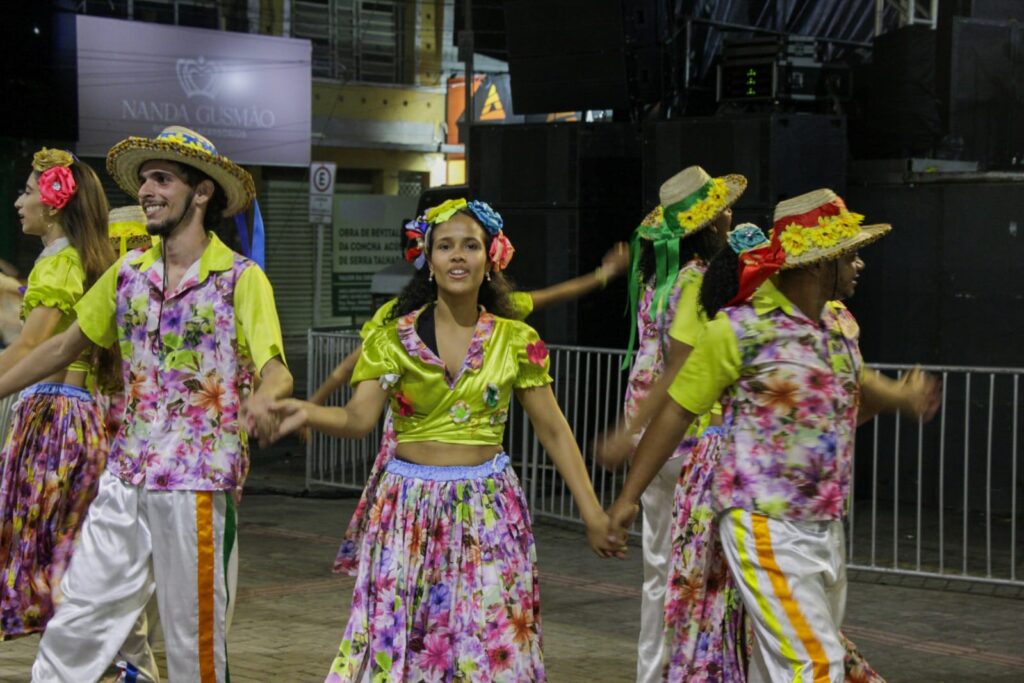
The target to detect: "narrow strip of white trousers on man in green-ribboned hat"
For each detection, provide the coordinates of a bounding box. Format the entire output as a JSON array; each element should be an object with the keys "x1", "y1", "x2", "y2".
[{"x1": 637, "y1": 458, "x2": 683, "y2": 683}]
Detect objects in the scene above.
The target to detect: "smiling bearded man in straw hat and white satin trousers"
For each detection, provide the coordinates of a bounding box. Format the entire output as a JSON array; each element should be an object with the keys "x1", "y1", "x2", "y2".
[{"x1": 0, "y1": 127, "x2": 292, "y2": 682}]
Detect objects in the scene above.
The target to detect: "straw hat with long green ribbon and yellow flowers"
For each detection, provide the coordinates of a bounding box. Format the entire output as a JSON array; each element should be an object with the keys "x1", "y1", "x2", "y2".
[{"x1": 623, "y1": 166, "x2": 746, "y2": 368}]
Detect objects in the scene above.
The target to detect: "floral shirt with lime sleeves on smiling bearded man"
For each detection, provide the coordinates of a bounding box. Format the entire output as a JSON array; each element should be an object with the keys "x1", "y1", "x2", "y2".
[{"x1": 77, "y1": 234, "x2": 284, "y2": 490}]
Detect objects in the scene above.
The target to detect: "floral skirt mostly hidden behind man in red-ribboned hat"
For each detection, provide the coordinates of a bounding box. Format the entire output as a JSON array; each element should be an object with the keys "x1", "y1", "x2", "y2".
[{"x1": 665, "y1": 427, "x2": 885, "y2": 683}]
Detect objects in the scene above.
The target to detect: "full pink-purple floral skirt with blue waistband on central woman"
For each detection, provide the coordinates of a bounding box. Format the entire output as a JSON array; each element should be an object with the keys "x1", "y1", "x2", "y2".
[{"x1": 327, "y1": 454, "x2": 546, "y2": 683}]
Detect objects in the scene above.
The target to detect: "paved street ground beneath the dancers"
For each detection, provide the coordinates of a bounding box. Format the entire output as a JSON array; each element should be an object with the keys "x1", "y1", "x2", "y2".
[{"x1": 0, "y1": 486, "x2": 1024, "y2": 683}]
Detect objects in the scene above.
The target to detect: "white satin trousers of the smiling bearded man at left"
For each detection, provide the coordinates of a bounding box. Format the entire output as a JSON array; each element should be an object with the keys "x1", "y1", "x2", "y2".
[{"x1": 32, "y1": 472, "x2": 238, "y2": 683}]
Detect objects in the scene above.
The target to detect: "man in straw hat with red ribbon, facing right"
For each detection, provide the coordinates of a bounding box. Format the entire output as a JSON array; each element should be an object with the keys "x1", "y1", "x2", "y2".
[{"x1": 610, "y1": 189, "x2": 937, "y2": 682}]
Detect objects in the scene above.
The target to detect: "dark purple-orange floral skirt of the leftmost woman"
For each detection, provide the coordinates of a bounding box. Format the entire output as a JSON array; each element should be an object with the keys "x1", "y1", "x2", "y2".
[{"x1": 0, "y1": 384, "x2": 108, "y2": 640}]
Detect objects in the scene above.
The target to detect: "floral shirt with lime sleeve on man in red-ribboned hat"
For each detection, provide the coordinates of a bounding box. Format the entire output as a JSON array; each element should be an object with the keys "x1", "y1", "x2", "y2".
[{"x1": 669, "y1": 282, "x2": 863, "y2": 520}]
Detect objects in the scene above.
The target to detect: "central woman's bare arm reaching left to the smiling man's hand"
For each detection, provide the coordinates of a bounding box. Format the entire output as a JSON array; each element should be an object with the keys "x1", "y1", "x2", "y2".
[{"x1": 272, "y1": 380, "x2": 387, "y2": 441}]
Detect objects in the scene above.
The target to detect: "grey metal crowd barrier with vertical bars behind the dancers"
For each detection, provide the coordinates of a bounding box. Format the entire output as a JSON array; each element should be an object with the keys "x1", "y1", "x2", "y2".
[{"x1": 306, "y1": 332, "x2": 1024, "y2": 587}]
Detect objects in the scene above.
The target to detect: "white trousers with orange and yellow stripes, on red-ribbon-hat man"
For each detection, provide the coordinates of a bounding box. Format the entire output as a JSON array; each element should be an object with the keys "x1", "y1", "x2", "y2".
[{"x1": 719, "y1": 509, "x2": 847, "y2": 683}]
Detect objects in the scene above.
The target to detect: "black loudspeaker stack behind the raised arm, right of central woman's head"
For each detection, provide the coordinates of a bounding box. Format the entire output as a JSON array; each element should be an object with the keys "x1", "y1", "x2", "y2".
[{"x1": 469, "y1": 123, "x2": 642, "y2": 348}]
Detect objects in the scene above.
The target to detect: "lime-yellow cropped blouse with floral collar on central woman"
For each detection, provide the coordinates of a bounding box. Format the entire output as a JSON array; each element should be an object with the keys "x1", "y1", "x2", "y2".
[{"x1": 352, "y1": 307, "x2": 551, "y2": 444}]
